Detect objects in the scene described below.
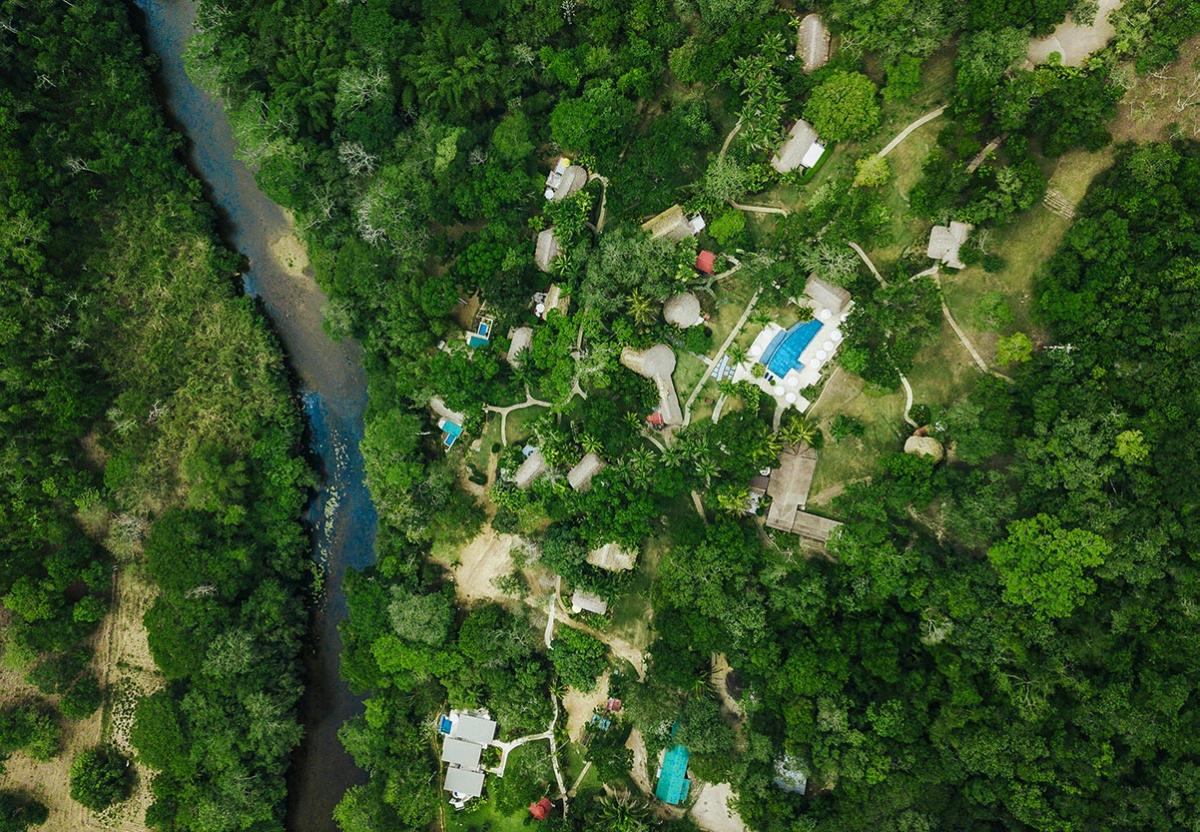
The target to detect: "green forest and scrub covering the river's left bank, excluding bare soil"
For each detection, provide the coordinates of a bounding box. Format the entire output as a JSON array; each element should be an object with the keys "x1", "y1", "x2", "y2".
[{"x1": 0, "y1": 0, "x2": 311, "y2": 831}]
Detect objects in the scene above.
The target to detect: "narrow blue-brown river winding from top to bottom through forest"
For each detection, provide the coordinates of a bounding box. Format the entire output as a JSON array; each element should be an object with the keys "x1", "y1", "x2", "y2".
[{"x1": 134, "y1": 0, "x2": 376, "y2": 832}]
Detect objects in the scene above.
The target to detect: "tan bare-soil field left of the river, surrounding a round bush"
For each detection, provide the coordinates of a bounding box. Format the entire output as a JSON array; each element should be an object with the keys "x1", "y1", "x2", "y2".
[{"x1": 0, "y1": 568, "x2": 162, "y2": 832}]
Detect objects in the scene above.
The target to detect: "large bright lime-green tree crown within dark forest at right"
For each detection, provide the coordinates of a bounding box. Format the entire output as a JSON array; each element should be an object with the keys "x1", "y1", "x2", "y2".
[{"x1": 988, "y1": 514, "x2": 1112, "y2": 618}]
